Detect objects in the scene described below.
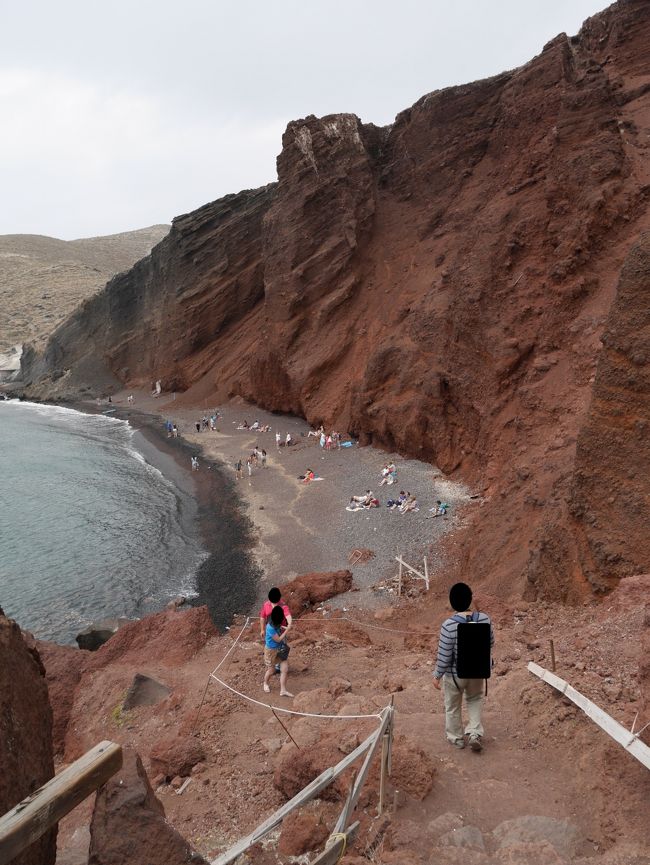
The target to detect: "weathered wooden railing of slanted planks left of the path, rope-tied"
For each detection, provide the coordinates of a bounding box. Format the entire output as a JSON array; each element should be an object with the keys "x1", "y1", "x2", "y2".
[{"x1": 211, "y1": 704, "x2": 394, "y2": 865}]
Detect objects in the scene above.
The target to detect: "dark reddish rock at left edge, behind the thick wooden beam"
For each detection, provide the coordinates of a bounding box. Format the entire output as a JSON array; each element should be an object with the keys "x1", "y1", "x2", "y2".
[{"x1": 0, "y1": 611, "x2": 56, "y2": 865}]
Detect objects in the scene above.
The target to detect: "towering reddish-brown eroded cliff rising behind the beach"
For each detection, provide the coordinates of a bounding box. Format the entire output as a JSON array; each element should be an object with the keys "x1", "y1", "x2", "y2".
[{"x1": 25, "y1": 0, "x2": 650, "y2": 597}]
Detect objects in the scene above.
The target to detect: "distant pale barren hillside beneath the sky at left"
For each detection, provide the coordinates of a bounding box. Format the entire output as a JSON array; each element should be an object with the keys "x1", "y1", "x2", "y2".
[{"x1": 0, "y1": 225, "x2": 169, "y2": 352}]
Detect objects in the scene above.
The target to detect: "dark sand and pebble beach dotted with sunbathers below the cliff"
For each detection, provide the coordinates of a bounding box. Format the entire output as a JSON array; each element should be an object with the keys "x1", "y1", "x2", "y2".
[{"x1": 102, "y1": 393, "x2": 477, "y2": 627}]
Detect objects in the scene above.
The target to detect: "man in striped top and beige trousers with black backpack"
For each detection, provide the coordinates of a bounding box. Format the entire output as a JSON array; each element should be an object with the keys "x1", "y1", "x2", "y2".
[{"x1": 433, "y1": 583, "x2": 494, "y2": 751}]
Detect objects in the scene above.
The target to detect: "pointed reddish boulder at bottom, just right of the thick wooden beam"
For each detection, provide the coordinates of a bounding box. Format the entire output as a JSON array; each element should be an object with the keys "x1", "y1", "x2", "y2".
[{"x1": 88, "y1": 750, "x2": 205, "y2": 865}]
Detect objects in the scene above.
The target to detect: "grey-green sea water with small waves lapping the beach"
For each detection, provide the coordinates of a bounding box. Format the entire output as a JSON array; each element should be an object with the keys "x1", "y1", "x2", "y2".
[{"x1": 0, "y1": 401, "x2": 206, "y2": 643}]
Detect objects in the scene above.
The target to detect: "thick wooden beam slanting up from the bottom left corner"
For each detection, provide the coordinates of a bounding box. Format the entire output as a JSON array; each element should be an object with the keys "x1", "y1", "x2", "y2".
[{"x1": 0, "y1": 741, "x2": 122, "y2": 865}]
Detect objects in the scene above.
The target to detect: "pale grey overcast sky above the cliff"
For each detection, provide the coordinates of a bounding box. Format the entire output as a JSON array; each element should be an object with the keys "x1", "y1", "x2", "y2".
[{"x1": 0, "y1": 0, "x2": 607, "y2": 239}]
